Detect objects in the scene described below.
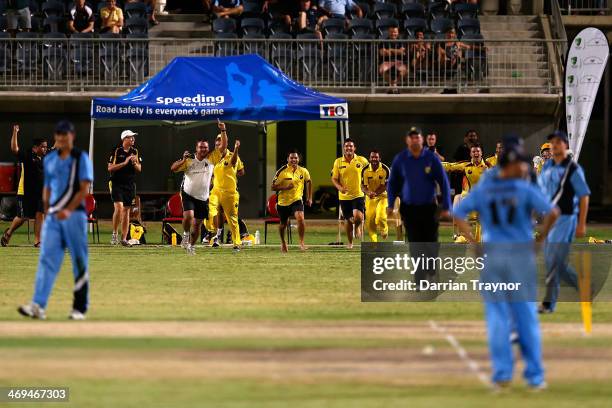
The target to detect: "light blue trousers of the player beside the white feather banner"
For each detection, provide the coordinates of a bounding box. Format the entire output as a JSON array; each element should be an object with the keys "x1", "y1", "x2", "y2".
[{"x1": 544, "y1": 215, "x2": 578, "y2": 310}]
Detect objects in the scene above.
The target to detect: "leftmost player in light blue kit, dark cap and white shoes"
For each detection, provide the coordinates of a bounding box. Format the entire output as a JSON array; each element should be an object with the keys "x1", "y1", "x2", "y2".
[{"x1": 17, "y1": 121, "x2": 93, "y2": 320}]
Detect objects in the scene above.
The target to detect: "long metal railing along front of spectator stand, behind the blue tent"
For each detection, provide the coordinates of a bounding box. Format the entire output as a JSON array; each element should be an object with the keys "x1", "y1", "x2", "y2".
[{"x1": 0, "y1": 38, "x2": 561, "y2": 93}]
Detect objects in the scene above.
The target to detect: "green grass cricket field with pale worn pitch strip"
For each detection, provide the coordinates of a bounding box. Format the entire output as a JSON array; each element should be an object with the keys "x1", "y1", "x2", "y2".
[{"x1": 0, "y1": 222, "x2": 612, "y2": 407}]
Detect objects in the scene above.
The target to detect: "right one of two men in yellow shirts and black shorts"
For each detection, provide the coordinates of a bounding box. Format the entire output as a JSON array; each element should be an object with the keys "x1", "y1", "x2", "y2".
[{"x1": 332, "y1": 138, "x2": 368, "y2": 249}]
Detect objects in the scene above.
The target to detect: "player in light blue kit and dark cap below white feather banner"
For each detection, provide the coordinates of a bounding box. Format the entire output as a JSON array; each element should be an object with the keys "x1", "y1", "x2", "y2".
[{"x1": 538, "y1": 130, "x2": 591, "y2": 313}]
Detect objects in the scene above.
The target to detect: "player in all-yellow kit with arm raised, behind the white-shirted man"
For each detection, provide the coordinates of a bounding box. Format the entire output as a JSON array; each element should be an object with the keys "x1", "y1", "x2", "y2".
[{"x1": 208, "y1": 122, "x2": 242, "y2": 251}]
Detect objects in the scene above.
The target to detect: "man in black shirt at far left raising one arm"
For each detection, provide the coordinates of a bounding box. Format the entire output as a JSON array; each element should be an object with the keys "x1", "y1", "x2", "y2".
[{"x1": 0, "y1": 125, "x2": 47, "y2": 247}]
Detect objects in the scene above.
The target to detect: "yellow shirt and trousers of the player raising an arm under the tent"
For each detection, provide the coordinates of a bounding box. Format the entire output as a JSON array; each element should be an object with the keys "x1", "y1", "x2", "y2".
[{"x1": 207, "y1": 149, "x2": 244, "y2": 245}]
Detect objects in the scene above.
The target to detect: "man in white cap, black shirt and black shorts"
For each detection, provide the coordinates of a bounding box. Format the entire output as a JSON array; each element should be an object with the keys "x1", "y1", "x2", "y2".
[{"x1": 108, "y1": 130, "x2": 142, "y2": 246}]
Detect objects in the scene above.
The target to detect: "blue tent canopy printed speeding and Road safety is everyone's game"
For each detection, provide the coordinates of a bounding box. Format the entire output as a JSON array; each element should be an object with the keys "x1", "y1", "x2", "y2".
[{"x1": 91, "y1": 55, "x2": 348, "y2": 121}]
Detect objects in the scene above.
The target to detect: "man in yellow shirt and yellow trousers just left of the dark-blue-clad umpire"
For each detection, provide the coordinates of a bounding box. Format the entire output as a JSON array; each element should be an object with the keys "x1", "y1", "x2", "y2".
[{"x1": 361, "y1": 150, "x2": 389, "y2": 242}]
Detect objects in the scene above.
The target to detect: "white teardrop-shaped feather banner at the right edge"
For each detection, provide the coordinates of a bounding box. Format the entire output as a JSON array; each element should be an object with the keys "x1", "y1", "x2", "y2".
[{"x1": 565, "y1": 27, "x2": 610, "y2": 161}]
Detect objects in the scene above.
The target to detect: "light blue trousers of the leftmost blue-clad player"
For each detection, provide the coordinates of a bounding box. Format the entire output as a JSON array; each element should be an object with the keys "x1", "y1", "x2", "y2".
[{"x1": 32, "y1": 211, "x2": 89, "y2": 313}]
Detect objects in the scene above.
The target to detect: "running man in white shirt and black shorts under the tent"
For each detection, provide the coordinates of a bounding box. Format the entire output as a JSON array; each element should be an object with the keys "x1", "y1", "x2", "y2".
[{"x1": 170, "y1": 140, "x2": 214, "y2": 255}]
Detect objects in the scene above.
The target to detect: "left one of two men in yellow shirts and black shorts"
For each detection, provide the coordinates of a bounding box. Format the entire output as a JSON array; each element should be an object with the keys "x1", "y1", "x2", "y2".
[{"x1": 272, "y1": 150, "x2": 312, "y2": 252}]
